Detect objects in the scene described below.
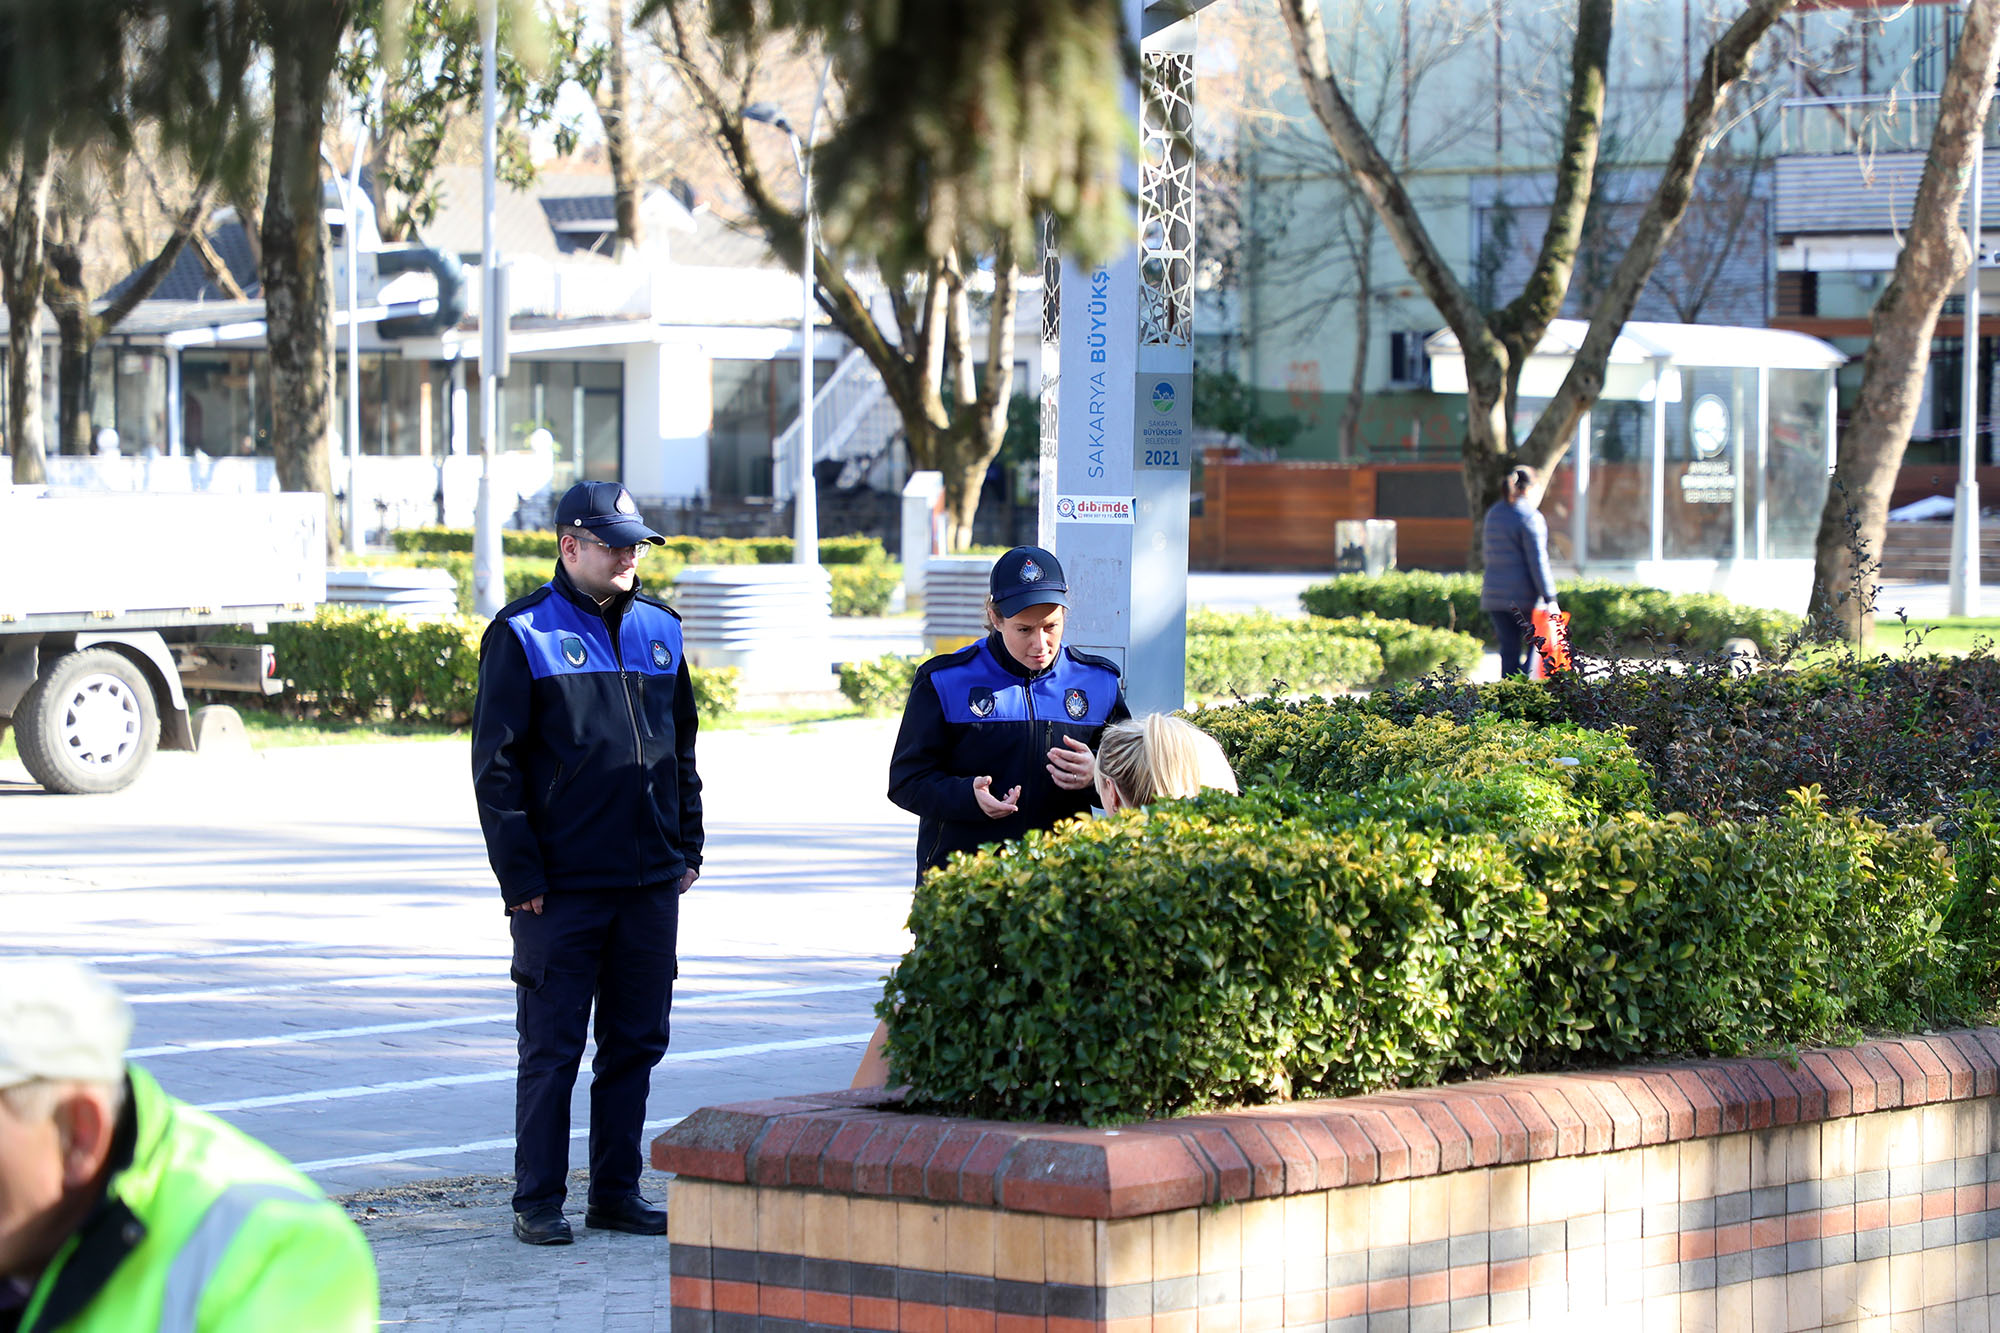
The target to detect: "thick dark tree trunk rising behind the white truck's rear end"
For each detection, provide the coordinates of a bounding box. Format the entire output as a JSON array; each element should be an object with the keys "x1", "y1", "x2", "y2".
[{"x1": 262, "y1": 0, "x2": 352, "y2": 554}]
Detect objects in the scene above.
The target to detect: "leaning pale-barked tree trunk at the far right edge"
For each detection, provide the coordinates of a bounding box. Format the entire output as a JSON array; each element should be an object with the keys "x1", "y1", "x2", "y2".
[{"x1": 1810, "y1": 0, "x2": 2000, "y2": 644}]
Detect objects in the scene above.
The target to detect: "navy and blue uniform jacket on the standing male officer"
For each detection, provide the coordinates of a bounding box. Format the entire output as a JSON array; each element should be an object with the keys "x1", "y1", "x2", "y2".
[{"x1": 472, "y1": 564, "x2": 702, "y2": 907}]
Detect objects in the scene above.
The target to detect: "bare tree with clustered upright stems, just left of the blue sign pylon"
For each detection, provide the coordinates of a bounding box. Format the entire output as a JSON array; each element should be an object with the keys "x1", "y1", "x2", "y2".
[{"x1": 654, "y1": 0, "x2": 1018, "y2": 548}]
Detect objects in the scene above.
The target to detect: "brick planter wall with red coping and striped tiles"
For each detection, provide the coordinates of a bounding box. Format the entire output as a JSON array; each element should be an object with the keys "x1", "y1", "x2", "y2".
[{"x1": 652, "y1": 1029, "x2": 2000, "y2": 1333}]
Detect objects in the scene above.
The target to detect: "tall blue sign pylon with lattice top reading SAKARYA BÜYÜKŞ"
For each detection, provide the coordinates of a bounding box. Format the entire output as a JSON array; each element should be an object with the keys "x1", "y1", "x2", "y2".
[{"x1": 1038, "y1": 0, "x2": 1208, "y2": 713}]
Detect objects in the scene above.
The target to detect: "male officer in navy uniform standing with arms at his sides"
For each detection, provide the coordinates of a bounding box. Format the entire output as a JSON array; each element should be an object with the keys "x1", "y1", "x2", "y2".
[{"x1": 472, "y1": 482, "x2": 702, "y2": 1245}]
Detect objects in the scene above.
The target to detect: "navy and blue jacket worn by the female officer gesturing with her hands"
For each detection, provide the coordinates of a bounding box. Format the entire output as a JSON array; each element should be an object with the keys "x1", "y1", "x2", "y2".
[{"x1": 888, "y1": 634, "x2": 1132, "y2": 875}]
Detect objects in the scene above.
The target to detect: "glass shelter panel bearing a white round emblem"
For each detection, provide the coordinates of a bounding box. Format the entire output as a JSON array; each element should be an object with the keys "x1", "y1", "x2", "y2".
[{"x1": 1662, "y1": 366, "x2": 1762, "y2": 560}]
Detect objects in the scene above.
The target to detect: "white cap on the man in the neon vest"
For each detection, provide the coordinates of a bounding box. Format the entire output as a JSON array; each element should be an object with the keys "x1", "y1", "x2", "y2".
[{"x1": 0, "y1": 957, "x2": 132, "y2": 1089}]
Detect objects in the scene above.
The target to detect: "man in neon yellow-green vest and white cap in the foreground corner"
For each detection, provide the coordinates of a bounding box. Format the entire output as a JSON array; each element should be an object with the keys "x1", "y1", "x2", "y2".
[{"x1": 0, "y1": 959, "x2": 376, "y2": 1333}]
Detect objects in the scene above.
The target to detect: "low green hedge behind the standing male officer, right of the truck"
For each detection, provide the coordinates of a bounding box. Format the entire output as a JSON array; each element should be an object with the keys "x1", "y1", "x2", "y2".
[{"x1": 270, "y1": 606, "x2": 738, "y2": 727}]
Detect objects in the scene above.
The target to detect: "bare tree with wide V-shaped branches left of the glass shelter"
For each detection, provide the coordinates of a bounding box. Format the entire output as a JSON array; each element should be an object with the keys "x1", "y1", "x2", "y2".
[{"x1": 1280, "y1": 0, "x2": 1794, "y2": 552}]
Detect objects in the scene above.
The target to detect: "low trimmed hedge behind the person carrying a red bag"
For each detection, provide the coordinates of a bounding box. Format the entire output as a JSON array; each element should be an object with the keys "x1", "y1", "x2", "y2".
[{"x1": 1300, "y1": 570, "x2": 1802, "y2": 652}]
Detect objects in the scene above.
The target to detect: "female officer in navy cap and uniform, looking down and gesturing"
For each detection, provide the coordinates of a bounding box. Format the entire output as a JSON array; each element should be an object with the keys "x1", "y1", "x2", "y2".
[{"x1": 888, "y1": 546, "x2": 1130, "y2": 879}]
